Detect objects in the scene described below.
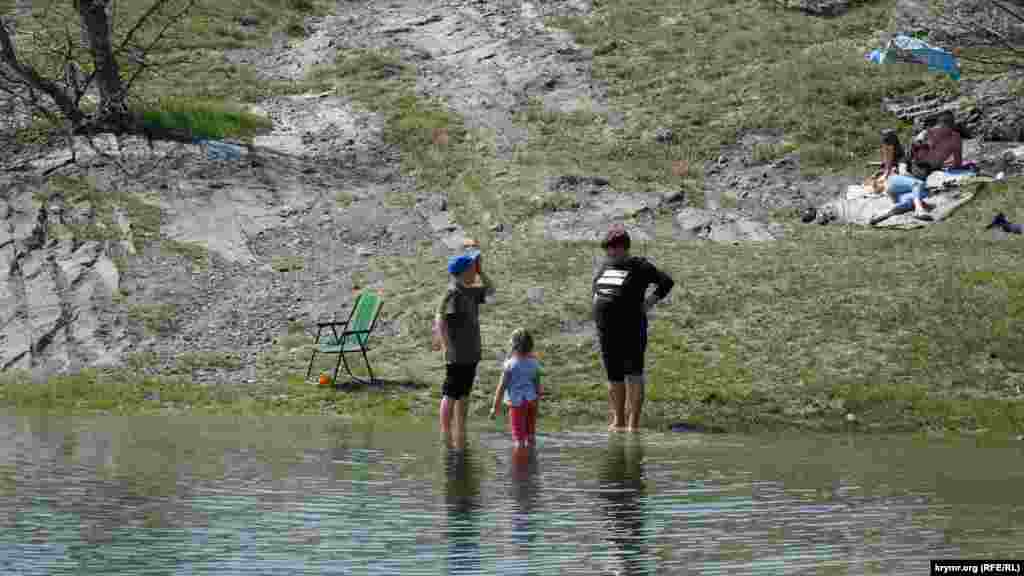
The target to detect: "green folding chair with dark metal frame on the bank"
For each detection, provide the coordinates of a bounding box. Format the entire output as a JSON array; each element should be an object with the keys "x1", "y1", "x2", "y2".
[{"x1": 306, "y1": 292, "x2": 383, "y2": 384}]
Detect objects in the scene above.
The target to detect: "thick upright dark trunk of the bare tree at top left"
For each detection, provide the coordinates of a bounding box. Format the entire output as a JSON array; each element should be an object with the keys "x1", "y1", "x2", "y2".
[{"x1": 78, "y1": 0, "x2": 128, "y2": 119}]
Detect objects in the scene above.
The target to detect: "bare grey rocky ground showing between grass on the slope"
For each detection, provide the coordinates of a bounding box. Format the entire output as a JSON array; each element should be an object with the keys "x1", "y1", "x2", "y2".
[{"x1": 0, "y1": 0, "x2": 1019, "y2": 383}]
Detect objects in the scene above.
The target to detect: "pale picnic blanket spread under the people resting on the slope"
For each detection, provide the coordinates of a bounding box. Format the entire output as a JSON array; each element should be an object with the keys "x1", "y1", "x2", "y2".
[{"x1": 821, "y1": 170, "x2": 991, "y2": 230}]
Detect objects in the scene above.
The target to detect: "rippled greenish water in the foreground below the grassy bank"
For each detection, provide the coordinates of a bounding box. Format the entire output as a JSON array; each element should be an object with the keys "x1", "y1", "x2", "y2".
[{"x1": 0, "y1": 416, "x2": 1024, "y2": 575}]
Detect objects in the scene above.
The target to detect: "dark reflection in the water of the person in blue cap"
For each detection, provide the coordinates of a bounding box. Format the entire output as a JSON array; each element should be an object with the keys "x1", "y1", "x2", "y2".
[{"x1": 444, "y1": 448, "x2": 480, "y2": 574}]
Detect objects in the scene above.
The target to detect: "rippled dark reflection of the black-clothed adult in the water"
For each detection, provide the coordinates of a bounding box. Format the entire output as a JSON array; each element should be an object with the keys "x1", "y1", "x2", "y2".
[{"x1": 600, "y1": 436, "x2": 655, "y2": 576}]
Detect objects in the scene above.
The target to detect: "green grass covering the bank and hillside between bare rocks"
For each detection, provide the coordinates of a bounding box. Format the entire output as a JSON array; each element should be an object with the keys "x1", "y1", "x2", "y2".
[{"x1": 8, "y1": 0, "x2": 1024, "y2": 434}]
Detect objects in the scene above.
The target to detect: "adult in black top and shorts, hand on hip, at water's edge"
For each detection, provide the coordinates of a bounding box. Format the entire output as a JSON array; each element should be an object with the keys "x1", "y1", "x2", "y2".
[{"x1": 592, "y1": 225, "x2": 675, "y2": 430}]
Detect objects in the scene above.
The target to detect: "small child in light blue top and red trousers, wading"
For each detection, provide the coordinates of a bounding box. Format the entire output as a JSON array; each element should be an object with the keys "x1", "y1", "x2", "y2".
[{"x1": 490, "y1": 328, "x2": 543, "y2": 448}]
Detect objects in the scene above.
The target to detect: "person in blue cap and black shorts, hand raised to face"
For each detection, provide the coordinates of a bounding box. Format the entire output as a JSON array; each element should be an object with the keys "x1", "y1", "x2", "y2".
[{"x1": 434, "y1": 243, "x2": 495, "y2": 447}]
